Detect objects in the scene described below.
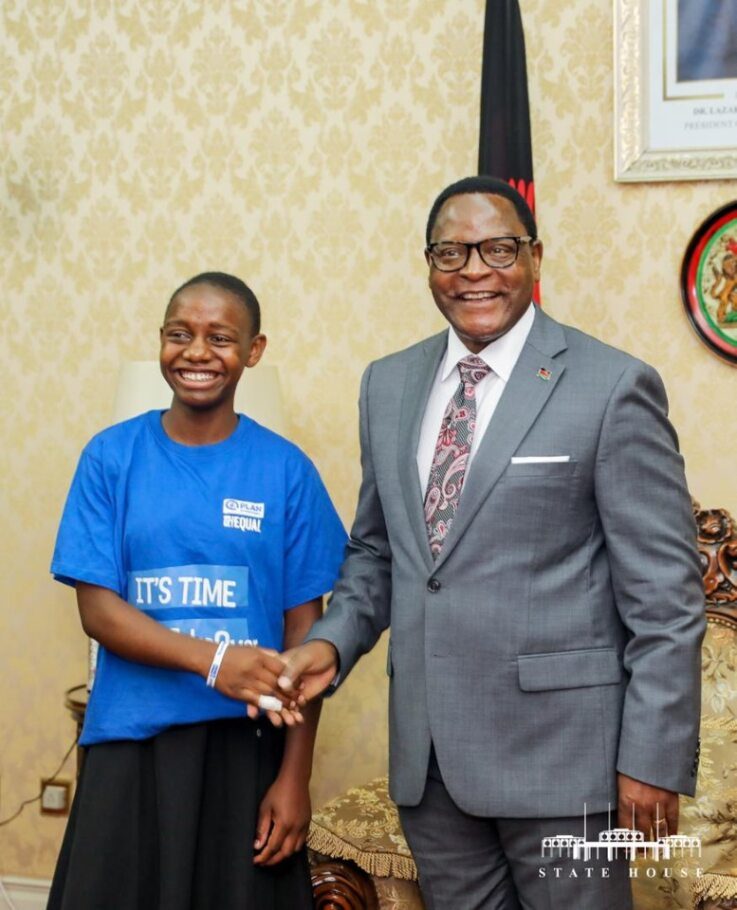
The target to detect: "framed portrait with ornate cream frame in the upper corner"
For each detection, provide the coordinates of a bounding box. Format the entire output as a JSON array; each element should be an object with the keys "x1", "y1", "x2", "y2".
[{"x1": 614, "y1": 0, "x2": 737, "y2": 181}]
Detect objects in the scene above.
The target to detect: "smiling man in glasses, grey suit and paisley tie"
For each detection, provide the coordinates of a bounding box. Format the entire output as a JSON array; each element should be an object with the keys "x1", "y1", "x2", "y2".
[{"x1": 281, "y1": 177, "x2": 705, "y2": 910}]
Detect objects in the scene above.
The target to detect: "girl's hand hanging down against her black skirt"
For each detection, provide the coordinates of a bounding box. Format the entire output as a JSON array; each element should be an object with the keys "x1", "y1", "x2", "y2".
[{"x1": 253, "y1": 774, "x2": 312, "y2": 866}]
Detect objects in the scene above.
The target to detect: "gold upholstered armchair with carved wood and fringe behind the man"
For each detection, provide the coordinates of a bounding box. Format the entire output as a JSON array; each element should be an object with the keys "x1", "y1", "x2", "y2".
[{"x1": 308, "y1": 503, "x2": 737, "y2": 910}]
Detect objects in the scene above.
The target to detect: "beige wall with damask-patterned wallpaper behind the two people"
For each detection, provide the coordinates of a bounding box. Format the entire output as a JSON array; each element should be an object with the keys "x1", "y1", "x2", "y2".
[{"x1": 0, "y1": 0, "x2": 737, "y2": 876}]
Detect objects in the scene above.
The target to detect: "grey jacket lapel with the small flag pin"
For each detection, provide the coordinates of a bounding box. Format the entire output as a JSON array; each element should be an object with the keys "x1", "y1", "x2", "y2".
[{"x1": 435, "y1": 310, "x2": 567, "y2": 568}]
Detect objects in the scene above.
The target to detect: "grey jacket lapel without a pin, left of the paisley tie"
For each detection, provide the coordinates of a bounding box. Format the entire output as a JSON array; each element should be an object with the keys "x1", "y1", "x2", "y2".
[{"x1": 397, "y1": 332, "x2": 448, "y2": 568}]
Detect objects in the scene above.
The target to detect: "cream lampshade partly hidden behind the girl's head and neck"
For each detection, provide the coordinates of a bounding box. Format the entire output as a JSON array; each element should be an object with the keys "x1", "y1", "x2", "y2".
[{"x1": 113, "y1": 360, "x2": 287, "y2": 435}]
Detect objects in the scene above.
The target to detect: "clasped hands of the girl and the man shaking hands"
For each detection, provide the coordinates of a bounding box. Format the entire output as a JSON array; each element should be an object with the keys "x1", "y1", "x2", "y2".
[{"x1": 207, "y1": 639, "x2": 339, "y2": 727}]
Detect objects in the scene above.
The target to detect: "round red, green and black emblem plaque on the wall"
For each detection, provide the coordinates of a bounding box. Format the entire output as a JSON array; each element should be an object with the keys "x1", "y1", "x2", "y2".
[{"x1": 681, "y1": 200, "x2": 737, "y2": 366}]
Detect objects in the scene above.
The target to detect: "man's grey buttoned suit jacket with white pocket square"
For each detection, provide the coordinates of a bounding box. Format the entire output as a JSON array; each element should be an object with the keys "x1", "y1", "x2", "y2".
[{"x1": 309, "y1": 311, "x2": 705, "y2": 817}]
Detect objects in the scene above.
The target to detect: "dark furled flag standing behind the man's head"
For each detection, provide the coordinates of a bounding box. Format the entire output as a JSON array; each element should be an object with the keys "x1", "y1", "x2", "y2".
[{"x1": 479, "y1": 0, "x2": 540, "y2": 303}]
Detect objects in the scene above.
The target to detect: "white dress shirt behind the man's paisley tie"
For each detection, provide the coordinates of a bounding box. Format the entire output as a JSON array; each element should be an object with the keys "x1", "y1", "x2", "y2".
[{"x1": 417, "y1": 303, "x2": 535, "y2": 494}]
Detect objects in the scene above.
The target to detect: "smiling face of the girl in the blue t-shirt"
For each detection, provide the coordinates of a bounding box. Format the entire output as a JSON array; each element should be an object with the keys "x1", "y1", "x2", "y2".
[{"x1": 159, "y1": 284, "x2": 266, "y2": 411}]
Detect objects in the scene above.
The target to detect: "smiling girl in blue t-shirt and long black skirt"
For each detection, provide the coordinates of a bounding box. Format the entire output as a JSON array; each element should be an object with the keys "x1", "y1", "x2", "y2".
[{"x1": 48, "y1": 272, "x2": 345, "y2": 910}]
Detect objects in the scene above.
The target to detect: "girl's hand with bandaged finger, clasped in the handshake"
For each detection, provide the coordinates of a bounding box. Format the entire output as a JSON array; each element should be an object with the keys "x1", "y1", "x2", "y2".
[{"x1": 215, "y1": 645, "x2": 302, "y2": 727}]
